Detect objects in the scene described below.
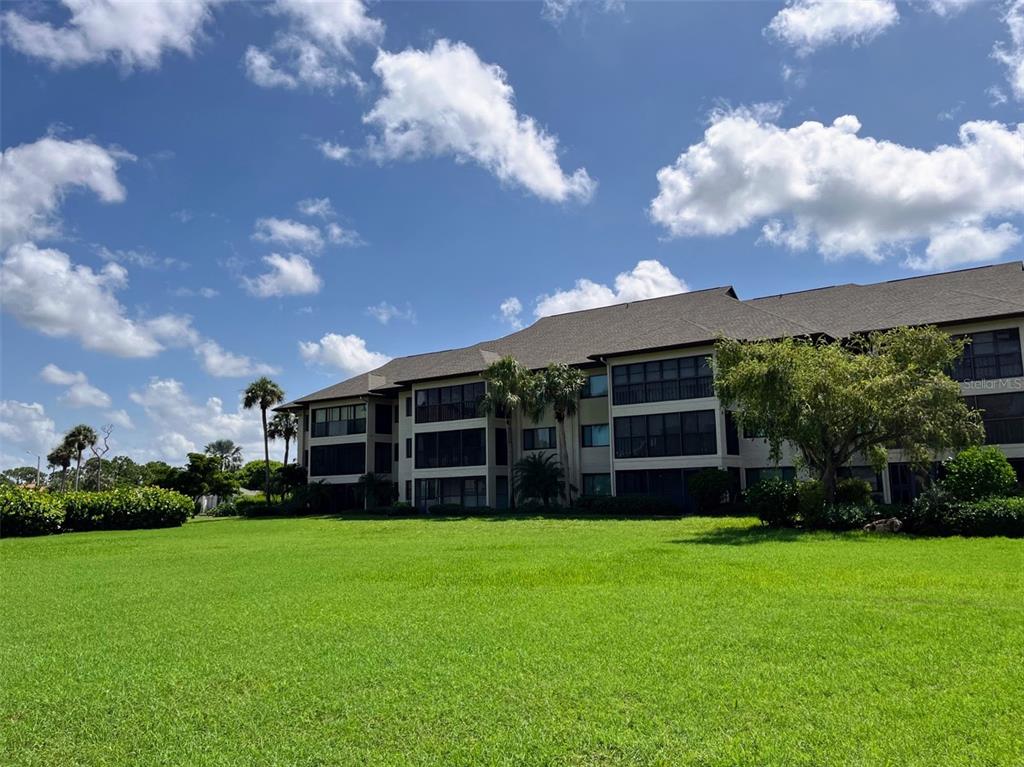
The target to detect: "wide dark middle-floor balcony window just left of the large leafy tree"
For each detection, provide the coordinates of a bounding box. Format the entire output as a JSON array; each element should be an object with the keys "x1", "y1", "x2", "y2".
[{"x1": 615, "y1": 411, "x2": 718, "y2": 458}]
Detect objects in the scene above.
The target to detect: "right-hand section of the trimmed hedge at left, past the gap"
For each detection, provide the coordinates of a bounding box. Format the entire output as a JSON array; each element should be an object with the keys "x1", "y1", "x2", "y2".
[{"x1": 63, "y1": 487, "x2": 195, "y2": 531}]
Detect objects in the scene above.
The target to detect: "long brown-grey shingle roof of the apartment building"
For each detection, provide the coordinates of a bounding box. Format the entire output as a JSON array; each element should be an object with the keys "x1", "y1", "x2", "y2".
[{"x1": 283, "y1": 261, "x2": 1024, "y2": 408}]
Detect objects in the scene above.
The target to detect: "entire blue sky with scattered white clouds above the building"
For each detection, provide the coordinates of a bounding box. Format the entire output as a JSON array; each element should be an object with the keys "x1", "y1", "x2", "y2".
[{"x1": 0, "y1": 0, "x2": 1024, "y2": 466}]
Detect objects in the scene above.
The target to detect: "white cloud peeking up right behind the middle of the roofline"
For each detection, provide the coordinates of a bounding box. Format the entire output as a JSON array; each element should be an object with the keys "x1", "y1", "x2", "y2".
[{"x1": 528, "y1": 260, "x2": 689, "y2": 317}]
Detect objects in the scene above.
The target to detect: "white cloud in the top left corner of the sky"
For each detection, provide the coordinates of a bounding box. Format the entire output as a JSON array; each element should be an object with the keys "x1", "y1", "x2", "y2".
[{"x1": 3, "y1": 0, "x2": 213, "y2": 71}]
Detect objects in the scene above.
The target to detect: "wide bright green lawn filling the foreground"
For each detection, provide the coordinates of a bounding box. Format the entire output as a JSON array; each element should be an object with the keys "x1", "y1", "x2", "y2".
[{"x1": 0, "y1": 518, "x2": 1024, "y2": 767}]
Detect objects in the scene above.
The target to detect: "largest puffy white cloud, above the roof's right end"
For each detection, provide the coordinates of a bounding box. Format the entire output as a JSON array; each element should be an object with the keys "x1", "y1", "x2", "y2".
[{"x1": 650, "y1": 112, "x2": 1024, "y2": 266}]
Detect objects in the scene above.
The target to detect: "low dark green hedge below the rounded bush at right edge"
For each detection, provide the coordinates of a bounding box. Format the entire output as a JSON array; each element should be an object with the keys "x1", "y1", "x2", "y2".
[{"x1": 904, "y1": 487, "x2": 1024, "y2": 538}]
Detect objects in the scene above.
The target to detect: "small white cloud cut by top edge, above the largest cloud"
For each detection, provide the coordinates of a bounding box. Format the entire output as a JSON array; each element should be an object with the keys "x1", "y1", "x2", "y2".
[{"x1": 765, "y1": 0, "x2": 899, "y2": 55}]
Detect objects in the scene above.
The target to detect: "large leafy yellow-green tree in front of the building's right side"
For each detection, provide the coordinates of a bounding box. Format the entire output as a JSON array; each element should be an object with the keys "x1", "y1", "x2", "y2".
[{"x1": 714, "y1": 328, "x2": 983, "y2": 501}]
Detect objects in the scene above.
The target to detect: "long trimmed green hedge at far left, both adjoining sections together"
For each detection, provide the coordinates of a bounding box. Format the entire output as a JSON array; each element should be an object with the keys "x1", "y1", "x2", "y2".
[{"x1": 0, "y1": 487, "x2": 194, "y2": 537}]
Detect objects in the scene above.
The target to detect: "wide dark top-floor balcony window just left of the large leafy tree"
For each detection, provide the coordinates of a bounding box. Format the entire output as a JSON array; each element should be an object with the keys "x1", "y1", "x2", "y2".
[{"x1": 611, "y1": 355, "x2": 712, "y2": 404}]
